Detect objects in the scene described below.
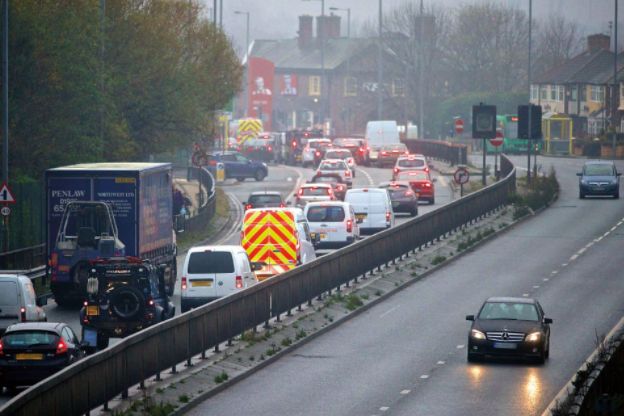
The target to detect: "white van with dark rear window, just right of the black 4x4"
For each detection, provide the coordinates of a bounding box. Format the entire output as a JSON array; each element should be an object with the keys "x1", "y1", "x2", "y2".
[{"x1": 180, "y1": 246, "x2": 254, "y2": 312}]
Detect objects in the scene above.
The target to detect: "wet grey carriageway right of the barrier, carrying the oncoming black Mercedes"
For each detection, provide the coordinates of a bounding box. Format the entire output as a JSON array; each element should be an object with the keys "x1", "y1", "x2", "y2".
[{"x1": 190, "y1": 157, "x2": 624, "y2": 416}]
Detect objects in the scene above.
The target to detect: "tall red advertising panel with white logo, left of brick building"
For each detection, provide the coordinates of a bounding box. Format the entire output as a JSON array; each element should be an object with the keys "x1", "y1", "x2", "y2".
[{"x1": 247, "y1": 57, "x2": 275, "y2": 131}]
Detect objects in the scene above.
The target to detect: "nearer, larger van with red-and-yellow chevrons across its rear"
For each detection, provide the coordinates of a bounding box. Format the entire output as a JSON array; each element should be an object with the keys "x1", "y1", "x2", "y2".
[{"x1": 241, "y1": 208, "x2": 316, "y2": 281}]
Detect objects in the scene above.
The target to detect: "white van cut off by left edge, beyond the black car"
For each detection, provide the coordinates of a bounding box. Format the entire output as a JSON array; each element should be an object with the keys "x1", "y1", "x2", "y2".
[{"x1": 0, "y1": 274, "x2": 47, "y2": 335}]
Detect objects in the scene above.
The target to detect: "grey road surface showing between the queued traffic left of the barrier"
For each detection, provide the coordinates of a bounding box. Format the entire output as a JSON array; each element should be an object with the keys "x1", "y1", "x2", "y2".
[{"x1": 0, "y1": 161, "x2": 453, "y2": 406}]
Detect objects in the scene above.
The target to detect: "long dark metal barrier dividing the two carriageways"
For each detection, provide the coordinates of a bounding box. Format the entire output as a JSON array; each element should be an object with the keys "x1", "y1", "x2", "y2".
[{"x1": 1, "y1": 156, "x2": 516, "y2": 415}]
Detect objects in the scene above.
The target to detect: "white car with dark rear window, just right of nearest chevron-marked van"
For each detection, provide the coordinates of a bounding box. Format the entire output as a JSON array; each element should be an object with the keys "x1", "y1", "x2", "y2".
[{"x1": 304, "y1": 201, "x2": 360, "y2": 248}]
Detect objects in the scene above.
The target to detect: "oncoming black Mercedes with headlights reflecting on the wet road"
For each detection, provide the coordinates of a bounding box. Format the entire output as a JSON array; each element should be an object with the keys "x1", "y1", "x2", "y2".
[{"x1": 466, "y1": 297, "x2": 552, "y2": 364}]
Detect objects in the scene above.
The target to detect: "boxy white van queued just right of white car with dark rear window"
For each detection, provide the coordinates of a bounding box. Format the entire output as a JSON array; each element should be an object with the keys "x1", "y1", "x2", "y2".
[{"x1": 345, "y1": 188, "x2": 394, "y2": 233}]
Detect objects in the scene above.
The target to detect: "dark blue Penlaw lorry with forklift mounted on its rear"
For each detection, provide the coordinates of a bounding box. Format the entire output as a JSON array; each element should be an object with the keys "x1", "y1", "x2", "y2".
[{"x1": 45, "y1": 163, "x2": 176, "y2": 305}]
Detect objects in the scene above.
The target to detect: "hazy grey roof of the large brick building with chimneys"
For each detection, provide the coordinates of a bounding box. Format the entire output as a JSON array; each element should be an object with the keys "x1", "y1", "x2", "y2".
[{"x1": 250, "y1": 38, "x2": 374, "y2": 70}]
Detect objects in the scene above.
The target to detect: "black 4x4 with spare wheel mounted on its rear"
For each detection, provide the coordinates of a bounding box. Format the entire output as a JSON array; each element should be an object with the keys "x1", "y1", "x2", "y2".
[{"x1": 80, "y1": 257, "x2": 175, "y2": 350}]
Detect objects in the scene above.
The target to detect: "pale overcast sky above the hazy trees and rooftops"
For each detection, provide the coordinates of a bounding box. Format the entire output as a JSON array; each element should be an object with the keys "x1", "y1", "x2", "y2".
[{"x1": 200, "y1": 0, "x2": 624, "y2": 51}]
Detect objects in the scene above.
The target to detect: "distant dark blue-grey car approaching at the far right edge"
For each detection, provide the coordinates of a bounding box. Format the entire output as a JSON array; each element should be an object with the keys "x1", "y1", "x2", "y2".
[{"x1": 576, "y1": 160, "x2": 621, "y2": 199}]
